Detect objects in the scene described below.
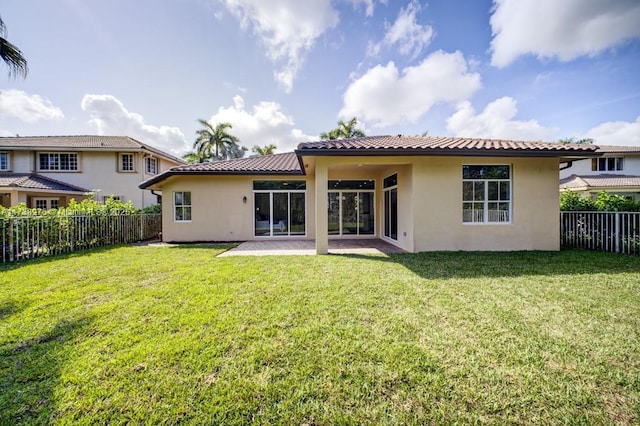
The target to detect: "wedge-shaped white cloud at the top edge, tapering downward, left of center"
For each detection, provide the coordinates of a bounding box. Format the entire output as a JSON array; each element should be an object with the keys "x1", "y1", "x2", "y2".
[{"x1": 222, "y1": 0, "x2": 338, "y2": 92}]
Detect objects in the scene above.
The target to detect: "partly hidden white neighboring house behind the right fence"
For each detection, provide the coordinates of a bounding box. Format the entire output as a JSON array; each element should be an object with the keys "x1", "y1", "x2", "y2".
[{"x1": 560, "y1": 145, "x2": 640, "y2": 201}]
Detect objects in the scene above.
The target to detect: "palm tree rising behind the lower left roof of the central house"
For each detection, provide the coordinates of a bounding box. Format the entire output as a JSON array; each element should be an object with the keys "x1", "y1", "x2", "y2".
[{"x1": 192, "y1": 119, "x2": 247, "y2": 163}]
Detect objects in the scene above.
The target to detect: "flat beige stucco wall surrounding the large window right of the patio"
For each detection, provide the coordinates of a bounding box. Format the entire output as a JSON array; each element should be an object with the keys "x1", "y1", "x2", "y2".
[{"x1": 413, "y1": 157, "x2": 560, "y2": 251}]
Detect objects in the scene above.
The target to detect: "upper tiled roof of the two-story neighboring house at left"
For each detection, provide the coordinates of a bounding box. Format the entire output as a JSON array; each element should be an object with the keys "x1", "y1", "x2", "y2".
[{"x1": 0, "y1": 135, "x2": 185, "y2": 164}]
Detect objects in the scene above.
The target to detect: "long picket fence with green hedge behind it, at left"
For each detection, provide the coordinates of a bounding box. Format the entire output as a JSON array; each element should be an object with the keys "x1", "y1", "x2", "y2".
[{"x1": 0, "y1": 213, "x2": 162, "y2": 263}]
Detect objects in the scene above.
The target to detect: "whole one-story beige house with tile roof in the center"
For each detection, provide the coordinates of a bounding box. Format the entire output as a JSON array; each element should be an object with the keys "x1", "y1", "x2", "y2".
[{"x1": 140, "y1": 135, "x2": 598, "y2": 254}]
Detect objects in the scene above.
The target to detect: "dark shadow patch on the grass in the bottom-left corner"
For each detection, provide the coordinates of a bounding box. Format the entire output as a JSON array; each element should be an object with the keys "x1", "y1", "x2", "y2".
[{"x1": 0, "y1": 318, "x2": 91, "y2": 425}]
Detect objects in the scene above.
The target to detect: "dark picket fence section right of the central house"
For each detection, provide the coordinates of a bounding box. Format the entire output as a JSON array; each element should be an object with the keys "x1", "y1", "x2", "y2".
[{"x1": 560, "y1": 212, "x2": 640, "y2": 255}]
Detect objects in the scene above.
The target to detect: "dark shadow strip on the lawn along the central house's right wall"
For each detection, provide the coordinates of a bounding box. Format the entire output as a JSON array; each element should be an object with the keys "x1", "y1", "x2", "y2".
[{"x1": 337, "y1": 249, "x2": 640, "y2": 279}]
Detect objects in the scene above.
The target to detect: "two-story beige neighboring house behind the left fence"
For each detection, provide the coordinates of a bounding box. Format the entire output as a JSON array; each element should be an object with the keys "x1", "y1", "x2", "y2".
[{"x1": 0, "y1": 136, "x2": 185, "y2": 208}]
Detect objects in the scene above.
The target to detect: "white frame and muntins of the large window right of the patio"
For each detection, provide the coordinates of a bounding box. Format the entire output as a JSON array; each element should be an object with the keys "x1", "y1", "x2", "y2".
[{"x1": 462, "y1": 164, "x2": 513, "y2": 225}]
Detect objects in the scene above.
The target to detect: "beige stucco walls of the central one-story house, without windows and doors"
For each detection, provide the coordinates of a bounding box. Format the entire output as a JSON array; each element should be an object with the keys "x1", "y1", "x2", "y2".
[{"x1": 156, "y1": 156, "x2": 559, "y2": 253}]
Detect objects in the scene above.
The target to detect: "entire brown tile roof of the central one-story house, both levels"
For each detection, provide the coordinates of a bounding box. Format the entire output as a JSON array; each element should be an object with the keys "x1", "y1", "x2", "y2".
[{"x1": 139, "y1": 135, "x2": 600, "y2": 189}]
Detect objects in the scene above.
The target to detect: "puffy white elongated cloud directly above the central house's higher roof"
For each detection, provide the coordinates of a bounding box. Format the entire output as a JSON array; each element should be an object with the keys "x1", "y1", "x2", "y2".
[{"x1": 339, "y1": 51, "x2": 481, "y2": 127}]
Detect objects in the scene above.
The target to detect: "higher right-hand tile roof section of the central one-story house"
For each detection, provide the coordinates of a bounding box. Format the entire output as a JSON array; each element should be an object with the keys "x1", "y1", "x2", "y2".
[{"x1": 296, "y1": 135, "x2": 597, "y2": 156}]
